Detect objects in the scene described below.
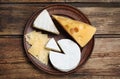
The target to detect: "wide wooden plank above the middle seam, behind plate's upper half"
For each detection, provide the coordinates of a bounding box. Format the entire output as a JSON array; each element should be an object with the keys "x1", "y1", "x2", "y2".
[{"x1": 0, "y1": 4, "x2": 120, "y2": 35}]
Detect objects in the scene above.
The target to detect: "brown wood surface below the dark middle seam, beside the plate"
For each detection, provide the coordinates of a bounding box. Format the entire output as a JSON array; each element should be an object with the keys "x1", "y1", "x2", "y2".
[{"x1": 0, "y1": 37, "x2": 120, "y2": 79}]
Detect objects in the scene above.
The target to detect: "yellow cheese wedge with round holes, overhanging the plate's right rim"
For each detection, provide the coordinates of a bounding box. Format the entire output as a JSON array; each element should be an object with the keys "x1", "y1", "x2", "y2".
[{"x1": 53, "y1": 15, "x2": 96, "y2": 47}]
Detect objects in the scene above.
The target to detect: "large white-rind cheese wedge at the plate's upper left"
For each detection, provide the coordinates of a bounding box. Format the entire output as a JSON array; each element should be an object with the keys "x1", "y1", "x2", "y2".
[{"x1": 33, "y1": 10, "x2": 59, "y2": 34}]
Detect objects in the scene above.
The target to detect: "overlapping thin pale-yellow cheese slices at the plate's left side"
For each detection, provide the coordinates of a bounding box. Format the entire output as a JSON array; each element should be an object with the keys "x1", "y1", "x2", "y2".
[{"x1": 25, "y1": 31, "x2": 49, "y2": 65}]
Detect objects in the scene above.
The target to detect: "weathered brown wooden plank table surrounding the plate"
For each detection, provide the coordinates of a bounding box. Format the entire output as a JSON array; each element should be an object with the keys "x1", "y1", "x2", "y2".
[{"x1": 0, "y1": 0, "x2": 120, "y2": 79}]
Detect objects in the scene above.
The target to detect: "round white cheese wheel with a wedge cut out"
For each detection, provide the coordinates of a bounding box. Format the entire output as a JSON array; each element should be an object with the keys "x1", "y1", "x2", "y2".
[{"x1": 49, "y1": 39, "x2": 81, "y2": 72}]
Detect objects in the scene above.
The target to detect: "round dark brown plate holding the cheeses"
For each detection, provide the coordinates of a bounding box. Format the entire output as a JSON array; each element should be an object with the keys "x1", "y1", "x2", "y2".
[{"x1": 24, "y1": 5, "x2": 94, "y2": 75}]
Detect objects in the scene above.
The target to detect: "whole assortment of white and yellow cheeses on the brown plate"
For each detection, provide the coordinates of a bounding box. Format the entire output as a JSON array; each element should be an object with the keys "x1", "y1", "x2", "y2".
[{"x1": 25, "y1": 9, "x2": 96, "y2": 72}]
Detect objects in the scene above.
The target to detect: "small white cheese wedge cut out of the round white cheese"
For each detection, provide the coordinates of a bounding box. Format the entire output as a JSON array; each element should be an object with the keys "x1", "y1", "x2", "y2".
[{"x1": 46, "y1": 38, "x2": 61, "y2": 52}]
